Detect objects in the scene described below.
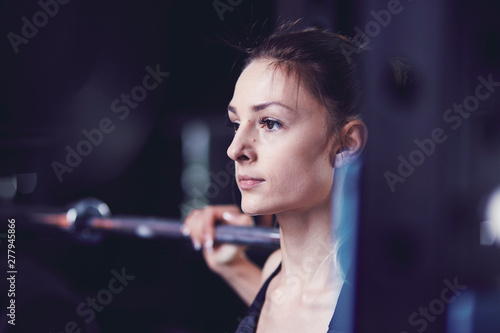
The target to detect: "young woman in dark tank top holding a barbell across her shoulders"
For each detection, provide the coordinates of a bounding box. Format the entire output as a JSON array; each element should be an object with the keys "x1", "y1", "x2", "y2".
[{"x1": 185, "y1": 24, "x2": 367, "y2": 333}]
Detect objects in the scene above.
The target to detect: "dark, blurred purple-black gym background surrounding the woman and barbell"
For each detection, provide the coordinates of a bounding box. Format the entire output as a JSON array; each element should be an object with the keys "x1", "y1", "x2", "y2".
[{"x1": 0, "y1": 0, "x2": 500, "y2": 333}]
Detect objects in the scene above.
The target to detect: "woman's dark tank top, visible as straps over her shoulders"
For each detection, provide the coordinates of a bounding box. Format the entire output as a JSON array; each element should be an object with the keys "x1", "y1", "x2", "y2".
[{"x1": 235, "y1": 264, "x2": 352, "y2": 333}]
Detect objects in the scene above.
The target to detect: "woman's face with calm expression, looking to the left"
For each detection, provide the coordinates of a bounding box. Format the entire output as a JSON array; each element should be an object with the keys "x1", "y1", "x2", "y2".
[{"x1": 227, "y1": 59, "x2": 338, "y2": 215}]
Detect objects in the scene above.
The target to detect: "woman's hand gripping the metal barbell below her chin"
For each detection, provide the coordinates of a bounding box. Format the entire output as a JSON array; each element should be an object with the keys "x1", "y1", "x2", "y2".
[{"x1": 184, "y1": 205, "x2": 253, "y2": 274}]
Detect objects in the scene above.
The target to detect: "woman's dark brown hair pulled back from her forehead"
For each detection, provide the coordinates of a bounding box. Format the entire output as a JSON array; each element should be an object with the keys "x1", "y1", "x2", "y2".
[{"x1": 244, "y1": 23, "x2": 362, "y2": 139}]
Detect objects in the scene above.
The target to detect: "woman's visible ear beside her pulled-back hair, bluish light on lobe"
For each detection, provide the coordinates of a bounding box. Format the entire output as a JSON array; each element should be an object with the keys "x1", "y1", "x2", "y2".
[{"x1": 335, "y1": 119, "x2": 368, "y2": 168}]
